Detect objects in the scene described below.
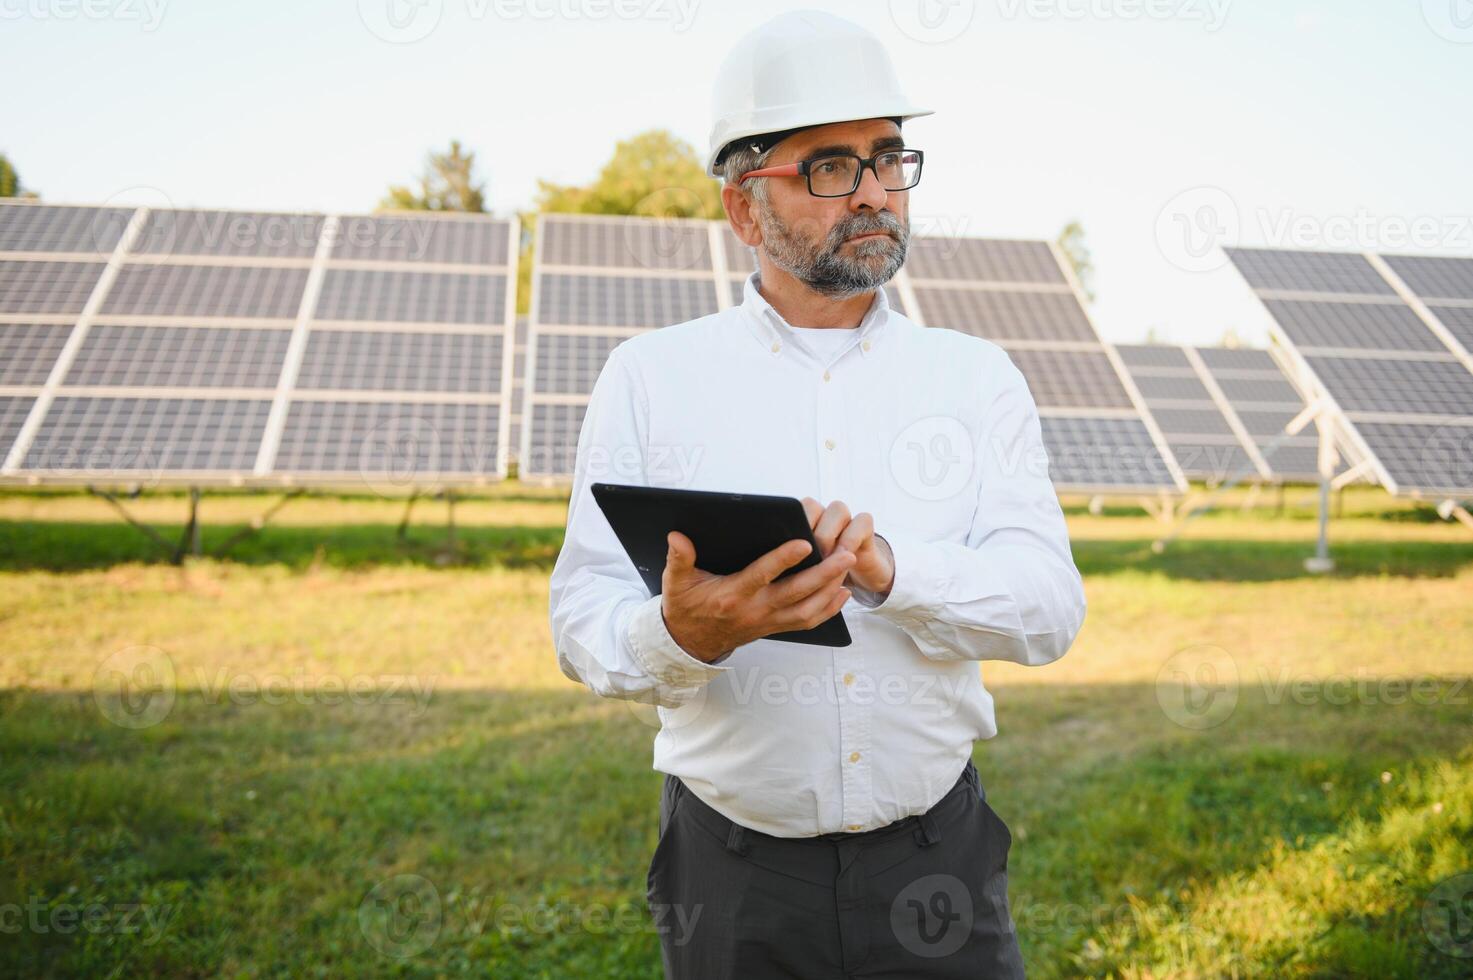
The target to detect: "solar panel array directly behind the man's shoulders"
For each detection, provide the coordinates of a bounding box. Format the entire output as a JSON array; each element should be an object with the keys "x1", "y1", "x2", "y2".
[{"x1": 520, "y1": 215, "x2": 1184, "y2": 492}]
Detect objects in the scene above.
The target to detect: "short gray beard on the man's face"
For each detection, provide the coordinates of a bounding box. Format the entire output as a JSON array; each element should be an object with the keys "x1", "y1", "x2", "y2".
[{"x1": 757, "y1": 202, "x2": 910, "y2": 299}]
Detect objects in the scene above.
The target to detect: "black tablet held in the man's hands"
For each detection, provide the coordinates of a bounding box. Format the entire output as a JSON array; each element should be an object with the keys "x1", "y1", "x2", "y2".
[{"x1": 591, "y1": 483, "x2": 851, "y2": 647}]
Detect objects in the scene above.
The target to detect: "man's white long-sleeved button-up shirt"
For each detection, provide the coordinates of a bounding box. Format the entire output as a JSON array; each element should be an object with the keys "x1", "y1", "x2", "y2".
[{"x1": 549, "y1": 274, "x2": 1084, "y2": 837}]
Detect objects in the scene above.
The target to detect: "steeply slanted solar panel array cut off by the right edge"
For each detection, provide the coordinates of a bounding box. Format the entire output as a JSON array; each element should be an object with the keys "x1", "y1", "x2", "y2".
[{"x1": 1228, "y1": 249, "x2": 1473, "y2": 498}]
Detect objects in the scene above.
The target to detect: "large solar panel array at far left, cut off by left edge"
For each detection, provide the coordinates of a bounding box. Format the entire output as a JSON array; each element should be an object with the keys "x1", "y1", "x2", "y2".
[{"x1": 0, "y1": 202, "x2": 518, "y2": 488}]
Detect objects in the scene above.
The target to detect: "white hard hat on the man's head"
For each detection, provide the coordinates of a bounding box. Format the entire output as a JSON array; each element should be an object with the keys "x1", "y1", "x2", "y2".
[{"x1": 706, "y1": 10, "x2": 932, "y2": 177}]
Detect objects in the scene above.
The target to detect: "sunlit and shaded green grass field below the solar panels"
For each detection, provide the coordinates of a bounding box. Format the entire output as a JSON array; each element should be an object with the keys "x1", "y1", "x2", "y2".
[{"x1": 0, "y1": 486, "x2": 1473, "y2": 977}]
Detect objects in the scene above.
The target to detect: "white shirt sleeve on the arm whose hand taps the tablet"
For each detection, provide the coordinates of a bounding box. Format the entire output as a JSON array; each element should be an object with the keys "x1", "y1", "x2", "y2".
[{"x1": 860, "y1": 351, "x2": 1086, "y2": 666}]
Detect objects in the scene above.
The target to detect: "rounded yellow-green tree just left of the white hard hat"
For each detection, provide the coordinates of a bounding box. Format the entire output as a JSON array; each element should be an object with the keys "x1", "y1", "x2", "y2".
[{"x1": 536, "y1": 130, "x2": 723, "y2": 218}]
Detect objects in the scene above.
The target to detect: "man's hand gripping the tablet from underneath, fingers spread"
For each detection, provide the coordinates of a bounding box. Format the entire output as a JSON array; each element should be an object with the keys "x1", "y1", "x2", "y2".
[{"x1": 660, "y1": 531, "x2": 854, "y2": 663}]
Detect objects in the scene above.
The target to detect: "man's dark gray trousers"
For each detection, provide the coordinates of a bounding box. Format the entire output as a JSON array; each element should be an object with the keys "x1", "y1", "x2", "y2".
[{"x1": 647, "y1": 760, "x2": 1024, "y2": 980}]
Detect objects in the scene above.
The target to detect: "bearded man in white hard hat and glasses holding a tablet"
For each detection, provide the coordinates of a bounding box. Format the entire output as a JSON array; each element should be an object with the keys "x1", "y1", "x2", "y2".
[{"x1": 551, "y1": 13, "x2": 1084, "y2": 980}]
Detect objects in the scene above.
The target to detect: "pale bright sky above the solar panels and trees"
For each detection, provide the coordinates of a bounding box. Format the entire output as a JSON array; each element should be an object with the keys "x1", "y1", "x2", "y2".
[{"x1": 0, "y1": 0, "x2": 1473, "y2": 343}]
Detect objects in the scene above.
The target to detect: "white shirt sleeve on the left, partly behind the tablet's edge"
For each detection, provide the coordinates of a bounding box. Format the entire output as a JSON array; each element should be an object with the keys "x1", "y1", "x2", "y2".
[{"x1": 548, "y1": 348, "x2": 731, "y2": 707}]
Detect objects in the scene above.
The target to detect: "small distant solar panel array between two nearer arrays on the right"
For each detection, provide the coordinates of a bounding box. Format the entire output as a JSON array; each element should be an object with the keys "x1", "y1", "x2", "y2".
[{"x1": 1117, "y1": 345, "x2": 1318, "y2": 485}]
